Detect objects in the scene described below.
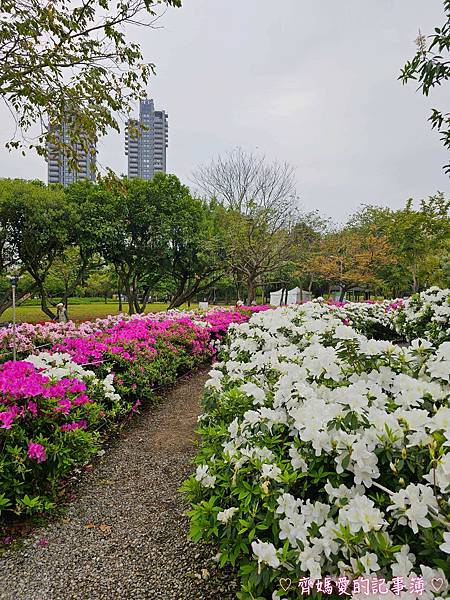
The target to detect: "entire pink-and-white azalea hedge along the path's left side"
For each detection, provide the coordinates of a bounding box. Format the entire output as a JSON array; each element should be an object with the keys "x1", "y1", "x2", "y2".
[{"x1": 0, "y1": 310, "x2": 264, "y2": 514}]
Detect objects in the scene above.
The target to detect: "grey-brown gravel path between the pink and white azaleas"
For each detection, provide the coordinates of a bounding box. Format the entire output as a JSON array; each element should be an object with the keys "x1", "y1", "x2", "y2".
[{"x1": 0, "y1": 373, "x2": 236, "y2": 600}]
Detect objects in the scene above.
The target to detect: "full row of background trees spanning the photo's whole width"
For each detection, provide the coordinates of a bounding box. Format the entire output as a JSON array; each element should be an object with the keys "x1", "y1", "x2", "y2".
[{"x1": 0, "y1": 173, "x2": 450, "y2": 318}]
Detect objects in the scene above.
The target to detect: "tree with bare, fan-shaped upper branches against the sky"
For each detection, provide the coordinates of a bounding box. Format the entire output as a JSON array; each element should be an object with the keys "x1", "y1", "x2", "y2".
[{"x1": 194, "y1": 149, "x2": 297, "y2": 304}]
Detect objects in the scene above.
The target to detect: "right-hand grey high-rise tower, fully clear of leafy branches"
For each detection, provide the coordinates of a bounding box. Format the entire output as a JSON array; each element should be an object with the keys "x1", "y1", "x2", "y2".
[{"x1": 125, "y1": 98, "x2": 169, "y2": 179}]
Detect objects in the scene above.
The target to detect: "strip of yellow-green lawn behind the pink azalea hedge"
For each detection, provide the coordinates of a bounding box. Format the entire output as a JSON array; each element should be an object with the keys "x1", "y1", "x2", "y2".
[{"x1": 0, "y1": 300, "x2": 197, "y2": 323}]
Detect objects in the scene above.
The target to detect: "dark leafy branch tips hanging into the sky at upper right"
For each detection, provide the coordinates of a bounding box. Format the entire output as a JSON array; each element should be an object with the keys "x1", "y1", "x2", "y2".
[{"x1": 400, "y1": 0, "x2": 450, "y2": 173}]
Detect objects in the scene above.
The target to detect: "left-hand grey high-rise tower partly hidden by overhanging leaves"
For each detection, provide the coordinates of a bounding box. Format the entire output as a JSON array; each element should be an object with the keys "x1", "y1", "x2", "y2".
[{"x1": 47, "y1": 123, "x2": 96, "y2": 186}]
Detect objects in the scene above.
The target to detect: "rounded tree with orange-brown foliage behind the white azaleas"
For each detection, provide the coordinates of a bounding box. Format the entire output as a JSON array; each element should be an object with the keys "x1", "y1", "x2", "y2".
[{"x1": 309, "y1": 229, "x2": 395, "y2": 300}]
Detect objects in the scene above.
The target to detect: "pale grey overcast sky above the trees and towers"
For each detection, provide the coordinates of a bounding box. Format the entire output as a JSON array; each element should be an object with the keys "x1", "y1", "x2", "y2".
[{"x1": 0, "y1": 0, "x2": 450, "y2": 221}]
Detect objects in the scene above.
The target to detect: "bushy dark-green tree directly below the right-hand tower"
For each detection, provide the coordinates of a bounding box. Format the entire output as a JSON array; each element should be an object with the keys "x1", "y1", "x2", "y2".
[{"x1": 100, "y1": 173, "x2": 218, "y2": 314}]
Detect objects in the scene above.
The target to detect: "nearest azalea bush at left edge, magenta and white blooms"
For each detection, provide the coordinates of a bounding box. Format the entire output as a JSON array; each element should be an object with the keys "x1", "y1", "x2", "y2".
[{"x1": 0, "y1": 354, "x2": 116, "y2": 514}]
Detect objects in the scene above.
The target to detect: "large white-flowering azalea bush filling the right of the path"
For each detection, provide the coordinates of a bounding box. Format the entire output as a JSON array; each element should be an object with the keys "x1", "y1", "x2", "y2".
[{"x1": 184, "y1": 302, "x2": 450, "y2": 600}]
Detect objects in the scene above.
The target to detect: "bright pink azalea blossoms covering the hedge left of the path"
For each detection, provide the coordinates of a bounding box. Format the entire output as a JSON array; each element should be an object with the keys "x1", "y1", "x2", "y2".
[{"x1": 0, "y1": 307, "x2": 267, "y2": 478}]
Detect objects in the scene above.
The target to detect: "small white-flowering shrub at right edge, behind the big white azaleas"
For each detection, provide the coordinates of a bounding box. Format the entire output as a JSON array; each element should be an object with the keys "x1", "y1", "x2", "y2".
[{"x1": 394, "y1": 287, "x2": 450, "y2": 344}]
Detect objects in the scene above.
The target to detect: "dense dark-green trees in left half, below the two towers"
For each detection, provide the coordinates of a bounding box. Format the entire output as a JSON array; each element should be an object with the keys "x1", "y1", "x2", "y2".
[{"x1": 0, "y1": 173, "x2": 223, "y2": 318}]
